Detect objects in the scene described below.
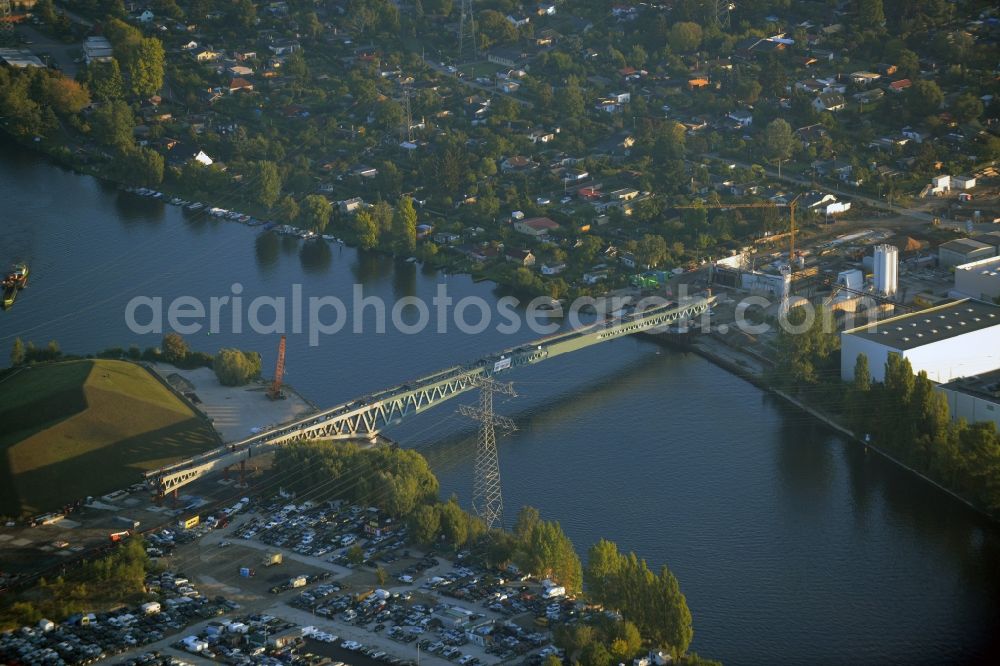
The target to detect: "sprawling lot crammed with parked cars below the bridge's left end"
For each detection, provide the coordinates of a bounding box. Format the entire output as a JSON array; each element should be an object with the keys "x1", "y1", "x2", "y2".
[{"x1": 0, "y1": 498, "x2": 578, "y2": 666}]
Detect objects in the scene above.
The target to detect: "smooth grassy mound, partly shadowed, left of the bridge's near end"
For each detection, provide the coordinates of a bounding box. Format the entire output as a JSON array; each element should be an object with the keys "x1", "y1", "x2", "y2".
[{"x1": 0, "y1": 360, "x2": 218, "y2": 516}]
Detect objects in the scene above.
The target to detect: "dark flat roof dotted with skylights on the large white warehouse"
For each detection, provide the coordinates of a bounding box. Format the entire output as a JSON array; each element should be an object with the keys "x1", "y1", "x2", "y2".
[{"x1": 844, "y1": 299, "x2": 1000, "y2": 351}]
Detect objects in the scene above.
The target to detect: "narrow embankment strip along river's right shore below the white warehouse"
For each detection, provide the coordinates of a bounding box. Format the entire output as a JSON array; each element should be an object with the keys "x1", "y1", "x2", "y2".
[{"x1": 686, "y1": 333, "x2": 1000, "y2": 523}]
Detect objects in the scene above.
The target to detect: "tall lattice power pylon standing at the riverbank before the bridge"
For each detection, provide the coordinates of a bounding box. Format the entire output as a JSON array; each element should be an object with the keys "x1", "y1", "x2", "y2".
[{"x1": 458, "y1": 377, "x2": 517, "y2": 529}]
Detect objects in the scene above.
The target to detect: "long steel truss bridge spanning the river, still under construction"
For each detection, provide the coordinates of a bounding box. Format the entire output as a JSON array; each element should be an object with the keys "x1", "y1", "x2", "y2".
[{"x1": 145, "y1": 296, "x2": 714, "y2": 516}]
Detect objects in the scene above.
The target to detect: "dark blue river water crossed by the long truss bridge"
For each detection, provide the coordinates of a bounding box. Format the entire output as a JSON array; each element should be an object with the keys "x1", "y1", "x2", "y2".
[{"x1": 0, "y1": 137, "x2": 1000, "y2": 664}]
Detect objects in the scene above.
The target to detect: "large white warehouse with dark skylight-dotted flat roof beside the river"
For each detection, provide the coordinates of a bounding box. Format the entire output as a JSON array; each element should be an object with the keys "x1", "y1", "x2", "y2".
[{"x1": 840, "y1": 299, "x2": 1000, "y2": 383}]
